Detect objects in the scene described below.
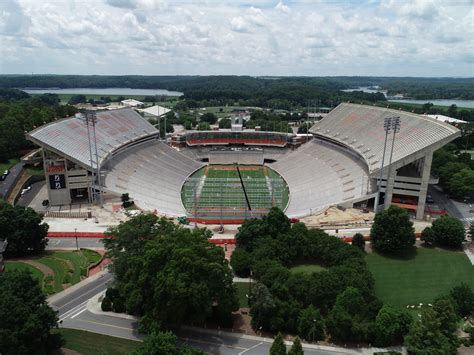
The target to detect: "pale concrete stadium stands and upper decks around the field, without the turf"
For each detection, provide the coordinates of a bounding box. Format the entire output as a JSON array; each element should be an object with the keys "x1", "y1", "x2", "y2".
[{"x1": 27, "y1": 103, "x2": 460, "y2": 225}]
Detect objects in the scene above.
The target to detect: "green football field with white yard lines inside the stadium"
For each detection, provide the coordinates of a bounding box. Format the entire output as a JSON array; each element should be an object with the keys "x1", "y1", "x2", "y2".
[{"x1": 181, "y1": 165, "x2": 289, "y2": 220}]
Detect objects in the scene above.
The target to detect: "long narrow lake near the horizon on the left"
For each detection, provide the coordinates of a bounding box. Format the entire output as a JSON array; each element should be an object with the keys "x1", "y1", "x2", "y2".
[{"x1": 20, "y1": 88, "x2": 183, "y2": 96}]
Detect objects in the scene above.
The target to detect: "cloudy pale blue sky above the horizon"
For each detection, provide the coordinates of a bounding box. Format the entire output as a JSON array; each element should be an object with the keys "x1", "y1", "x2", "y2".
[{"x1": 0, "y1": 0, "x2": 474, "y2": 77}]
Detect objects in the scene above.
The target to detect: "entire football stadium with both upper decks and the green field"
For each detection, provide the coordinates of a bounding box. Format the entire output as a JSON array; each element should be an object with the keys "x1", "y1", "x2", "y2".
[{"x1": 27, "y1": 103, "x2": 460, "y2": 224}]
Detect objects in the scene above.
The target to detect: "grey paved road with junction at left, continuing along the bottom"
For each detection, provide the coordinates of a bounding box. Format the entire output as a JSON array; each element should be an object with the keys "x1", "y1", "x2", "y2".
[{"x1": 50, "y1": 273, "x2": 353, "y2": 355}]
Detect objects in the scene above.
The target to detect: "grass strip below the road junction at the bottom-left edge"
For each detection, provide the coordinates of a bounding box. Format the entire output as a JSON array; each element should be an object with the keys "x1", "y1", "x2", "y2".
[{"x1": 53, "y1": 328, "x2": 141, "y2": 355}]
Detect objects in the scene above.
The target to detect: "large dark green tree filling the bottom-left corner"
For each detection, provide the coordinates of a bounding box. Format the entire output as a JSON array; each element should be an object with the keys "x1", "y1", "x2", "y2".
[{"x1": 0, "y1": 271, "x2": 62, "y2": 355}]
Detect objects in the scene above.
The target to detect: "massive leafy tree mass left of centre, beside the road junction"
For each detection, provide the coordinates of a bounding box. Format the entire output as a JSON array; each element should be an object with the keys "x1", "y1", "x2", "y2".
[{"x1": 104, "y1": 214, "x2": 238, "y2": 332}]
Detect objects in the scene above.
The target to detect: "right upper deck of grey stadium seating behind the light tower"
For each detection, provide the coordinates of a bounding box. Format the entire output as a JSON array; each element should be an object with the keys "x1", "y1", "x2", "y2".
[{"x1": 310, "y1": 103, "x2": 461, "y2": 175}]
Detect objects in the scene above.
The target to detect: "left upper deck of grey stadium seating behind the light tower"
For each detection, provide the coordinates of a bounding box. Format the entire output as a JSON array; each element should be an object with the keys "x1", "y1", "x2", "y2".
[{"x1": 27, "y1": 108, "x2": 158, "y2": 169}]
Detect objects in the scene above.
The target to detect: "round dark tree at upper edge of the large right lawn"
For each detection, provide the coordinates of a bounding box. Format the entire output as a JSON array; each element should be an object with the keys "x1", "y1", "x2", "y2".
[{"x1": 370, "y1": 206, "x2": 415, "y2": 253}]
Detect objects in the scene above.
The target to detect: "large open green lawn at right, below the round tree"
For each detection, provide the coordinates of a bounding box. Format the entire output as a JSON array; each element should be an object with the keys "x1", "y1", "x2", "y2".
[{"x1": 366, "y1": 248, "x2": 474, "y2": 307}]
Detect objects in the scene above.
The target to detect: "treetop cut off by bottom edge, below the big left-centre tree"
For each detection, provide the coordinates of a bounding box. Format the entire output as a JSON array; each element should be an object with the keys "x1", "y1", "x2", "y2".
[{"x1": 130, "y1": 332, "x2": 205, "y2": 355}]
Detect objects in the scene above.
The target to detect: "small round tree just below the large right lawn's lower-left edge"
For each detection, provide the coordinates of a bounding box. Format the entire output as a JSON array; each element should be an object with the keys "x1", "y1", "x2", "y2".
[{"x1": 374, "y1": 305, "x2": 412, "y2": 346}]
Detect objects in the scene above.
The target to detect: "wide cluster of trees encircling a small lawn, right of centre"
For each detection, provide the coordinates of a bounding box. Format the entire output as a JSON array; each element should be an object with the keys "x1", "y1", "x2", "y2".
[{"x1": 231, "y1": 208, "x2": 380, "y2": 340}]
